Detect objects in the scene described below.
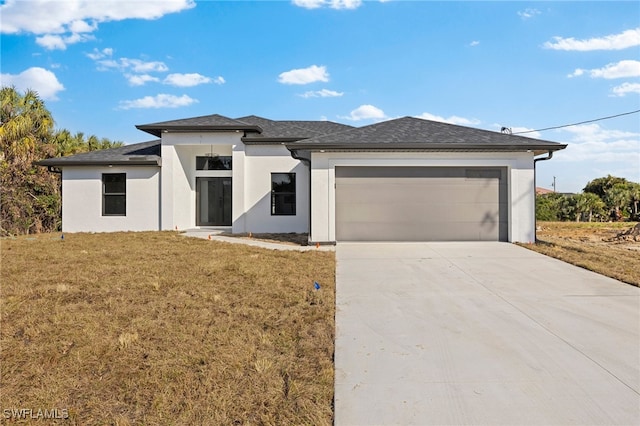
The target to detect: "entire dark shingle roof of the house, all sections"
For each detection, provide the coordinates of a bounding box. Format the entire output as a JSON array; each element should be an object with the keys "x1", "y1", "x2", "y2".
[{"x1": 36, "y1": 114, "x2": 567, "y2": 167}]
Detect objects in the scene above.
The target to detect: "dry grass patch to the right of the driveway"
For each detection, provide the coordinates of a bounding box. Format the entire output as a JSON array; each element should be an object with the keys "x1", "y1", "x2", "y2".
[{"x1": 522, "y1": 222, "x2": 640, "y2": 287}]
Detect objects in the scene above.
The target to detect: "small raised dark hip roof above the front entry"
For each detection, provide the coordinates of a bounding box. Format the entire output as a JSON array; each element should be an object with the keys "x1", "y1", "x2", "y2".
[{"x1": 136, "y1": 114, "x2": 262, "y2": 137}]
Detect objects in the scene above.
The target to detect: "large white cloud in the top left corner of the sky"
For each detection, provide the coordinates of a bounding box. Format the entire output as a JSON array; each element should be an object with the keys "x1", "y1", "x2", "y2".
[{"x1": 0, "y1": 0, "x2": 195, "y2": 50}]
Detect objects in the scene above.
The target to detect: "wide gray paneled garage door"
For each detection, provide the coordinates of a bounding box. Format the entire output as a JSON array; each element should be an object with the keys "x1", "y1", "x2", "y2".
[{"x1": 336, "y1": 167, "x2": 508, "y2": 241}]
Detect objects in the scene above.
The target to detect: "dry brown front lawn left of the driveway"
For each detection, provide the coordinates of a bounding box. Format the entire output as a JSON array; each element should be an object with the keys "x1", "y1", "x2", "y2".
[{"x1": 0, "y1": 232, "x2": 335, "y2": 425}]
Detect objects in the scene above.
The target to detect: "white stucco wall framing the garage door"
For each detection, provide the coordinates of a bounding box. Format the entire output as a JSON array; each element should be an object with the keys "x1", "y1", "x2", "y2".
[{"x1": 309, "y1": 152, "x2": 535, "y2": 242}]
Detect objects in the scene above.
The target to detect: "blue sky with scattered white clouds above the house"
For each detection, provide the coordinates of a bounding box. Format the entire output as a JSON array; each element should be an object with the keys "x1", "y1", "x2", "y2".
[{"x1": 0, "y1": 0, "x2": 640, "y2": 192}]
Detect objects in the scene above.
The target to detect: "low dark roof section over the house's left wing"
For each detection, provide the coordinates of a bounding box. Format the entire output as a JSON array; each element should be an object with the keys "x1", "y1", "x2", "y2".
[{"x1": 36, "y1": 139, "x2": 161, "y2": 167}]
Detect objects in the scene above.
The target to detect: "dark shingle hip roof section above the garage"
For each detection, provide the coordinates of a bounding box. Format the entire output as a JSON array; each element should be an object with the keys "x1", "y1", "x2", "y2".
[{"x1": 287, "y1": 117, "x2": 566, "y2": 154}]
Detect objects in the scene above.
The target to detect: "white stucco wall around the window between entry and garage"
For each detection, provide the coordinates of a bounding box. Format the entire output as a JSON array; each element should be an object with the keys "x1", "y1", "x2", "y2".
[{"x1": 241, "y1": 145, "x2": 309, "y2": 232}]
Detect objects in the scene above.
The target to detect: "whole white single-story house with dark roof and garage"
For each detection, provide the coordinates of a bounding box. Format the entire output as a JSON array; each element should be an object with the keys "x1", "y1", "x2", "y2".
[{"x1": 38, "y1": 115, "x2": 566, "y2": 243}]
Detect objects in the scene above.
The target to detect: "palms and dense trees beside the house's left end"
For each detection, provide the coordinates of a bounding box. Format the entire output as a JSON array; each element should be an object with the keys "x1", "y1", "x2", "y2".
[{"x1": 0, "y1": 87, "x2": 122, "y2": 236}]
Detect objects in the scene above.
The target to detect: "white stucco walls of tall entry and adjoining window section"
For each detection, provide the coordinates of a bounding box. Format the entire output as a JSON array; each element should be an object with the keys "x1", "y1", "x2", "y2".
[{"x1": 161, "y1": 132, "x2": 309, "y2": 233}]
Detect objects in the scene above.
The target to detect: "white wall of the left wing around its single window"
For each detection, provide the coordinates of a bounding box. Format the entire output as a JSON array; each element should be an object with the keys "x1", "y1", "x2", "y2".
[{"x1": 62, "y1": 166, "x2": 160, "y2": 232}]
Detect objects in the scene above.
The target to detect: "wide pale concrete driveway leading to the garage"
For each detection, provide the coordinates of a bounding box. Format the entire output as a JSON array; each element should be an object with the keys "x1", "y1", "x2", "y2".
[{"x1": 335, "y1": 243, "x2": 640, "y2": 425}]
